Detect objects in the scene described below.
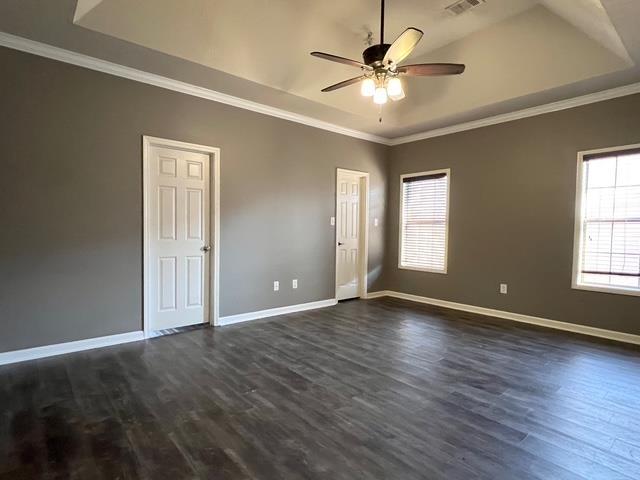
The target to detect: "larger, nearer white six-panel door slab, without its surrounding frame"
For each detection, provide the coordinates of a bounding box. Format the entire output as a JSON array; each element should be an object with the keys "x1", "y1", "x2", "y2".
[{"x1": 148, "y1": 146, "x2": 211, "y2": 330}]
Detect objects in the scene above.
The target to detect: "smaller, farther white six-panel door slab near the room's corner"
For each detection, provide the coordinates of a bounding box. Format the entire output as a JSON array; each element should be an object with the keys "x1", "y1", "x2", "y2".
[{"x1": 336, "y1": 171, "x2": 363, "y2": 300}]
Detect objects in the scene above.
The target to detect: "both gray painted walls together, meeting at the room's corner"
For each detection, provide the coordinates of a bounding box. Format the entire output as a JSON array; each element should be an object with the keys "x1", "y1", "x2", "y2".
[{"x1": 0, "y1": 44, "x2": 640, "y2": 352}]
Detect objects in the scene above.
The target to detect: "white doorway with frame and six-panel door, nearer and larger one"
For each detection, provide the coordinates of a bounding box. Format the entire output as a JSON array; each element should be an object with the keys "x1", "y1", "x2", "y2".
[{"x1": 143, "y1": 136, "x2": 220, "y2": 334}]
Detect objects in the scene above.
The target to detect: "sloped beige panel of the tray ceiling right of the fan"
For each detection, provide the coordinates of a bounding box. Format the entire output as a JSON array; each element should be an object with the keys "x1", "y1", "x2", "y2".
[{"x1": 398, "y1": 5, "x2": 629, "y2": 124}]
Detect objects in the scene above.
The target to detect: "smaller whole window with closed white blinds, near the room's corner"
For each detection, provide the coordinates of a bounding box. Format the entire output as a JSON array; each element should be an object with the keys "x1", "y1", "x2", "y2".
[{"x1": 398, "y1": 169, "x2": 451, "y2": 273}]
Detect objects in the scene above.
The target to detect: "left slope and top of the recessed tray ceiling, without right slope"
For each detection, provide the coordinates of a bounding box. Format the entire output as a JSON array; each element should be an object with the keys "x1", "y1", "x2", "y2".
[{"x1": 71, "y1": 0, "x2": 535, "y2": 123}]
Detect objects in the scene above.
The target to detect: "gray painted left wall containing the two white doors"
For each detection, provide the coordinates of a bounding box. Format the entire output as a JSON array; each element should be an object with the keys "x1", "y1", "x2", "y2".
[{"x1": 0, "y1": 48, "x2": 388, "y2": 351}]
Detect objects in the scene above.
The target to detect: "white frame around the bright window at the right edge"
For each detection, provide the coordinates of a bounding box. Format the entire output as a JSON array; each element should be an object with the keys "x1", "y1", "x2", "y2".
[{"x1": 571, "y1": 143, "x2": 640, "y2": 297}]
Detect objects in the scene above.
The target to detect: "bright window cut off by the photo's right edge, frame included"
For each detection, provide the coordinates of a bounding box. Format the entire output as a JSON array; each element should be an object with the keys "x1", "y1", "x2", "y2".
[{"x1": 573, "y1": 145, "x2": 640, "y2": 295}]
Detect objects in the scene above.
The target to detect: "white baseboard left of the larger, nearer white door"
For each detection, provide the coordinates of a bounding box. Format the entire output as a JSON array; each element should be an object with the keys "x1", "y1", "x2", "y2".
[{"x1": 0, "y1": 331, "x2": 145, "y2": 365}]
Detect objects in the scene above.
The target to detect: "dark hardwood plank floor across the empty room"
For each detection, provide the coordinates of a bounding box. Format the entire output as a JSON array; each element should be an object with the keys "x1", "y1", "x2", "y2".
[{"x1": 0, "y1": 299, "x2": 640, "y2": 480}]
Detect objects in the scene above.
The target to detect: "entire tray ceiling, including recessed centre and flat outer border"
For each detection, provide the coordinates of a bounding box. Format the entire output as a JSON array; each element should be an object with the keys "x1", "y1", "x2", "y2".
[{"x1": 0, "y1": 0, "x2": 640, "y2": 137}]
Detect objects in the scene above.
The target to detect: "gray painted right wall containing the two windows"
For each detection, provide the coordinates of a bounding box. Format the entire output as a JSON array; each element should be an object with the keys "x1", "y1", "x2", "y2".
[{"x1": 384, "y1": 95, "x2": 640, "y2": 334}]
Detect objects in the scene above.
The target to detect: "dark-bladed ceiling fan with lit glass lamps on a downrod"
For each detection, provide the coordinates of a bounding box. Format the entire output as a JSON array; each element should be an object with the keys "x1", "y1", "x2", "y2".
[{"x1": 311, "y1": 0, "x2": 465, "y2": 105}]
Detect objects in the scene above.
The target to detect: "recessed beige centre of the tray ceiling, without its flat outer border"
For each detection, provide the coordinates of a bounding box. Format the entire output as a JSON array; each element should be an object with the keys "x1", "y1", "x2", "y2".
[{"x1": 75, "y1": 0, "x2": 632, "y2": 134}]
